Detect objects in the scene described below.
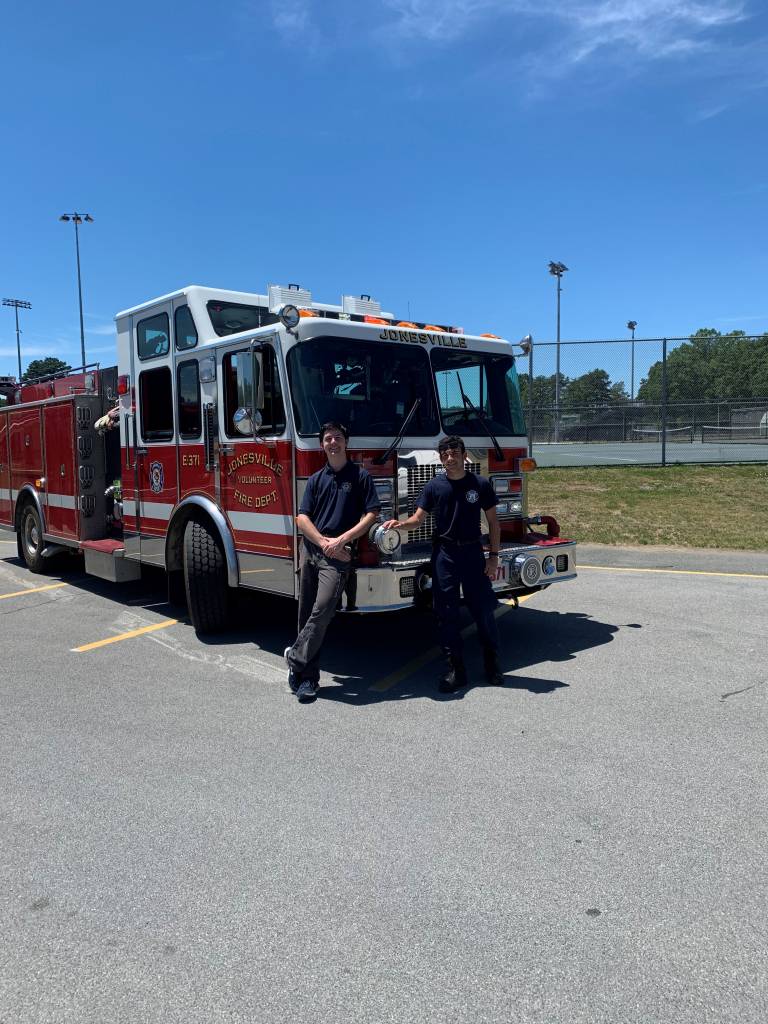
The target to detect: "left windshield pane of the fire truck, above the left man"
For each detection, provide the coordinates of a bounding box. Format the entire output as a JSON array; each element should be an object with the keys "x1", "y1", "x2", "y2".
[{"x1": 288, "y1": 337, "x2": 439, "y2": 438}]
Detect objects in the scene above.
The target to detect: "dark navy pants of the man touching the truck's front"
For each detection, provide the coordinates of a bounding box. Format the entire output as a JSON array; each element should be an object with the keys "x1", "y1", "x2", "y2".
[{"x1": 432, "y1": 543, "x2": 499, "y2": 657}]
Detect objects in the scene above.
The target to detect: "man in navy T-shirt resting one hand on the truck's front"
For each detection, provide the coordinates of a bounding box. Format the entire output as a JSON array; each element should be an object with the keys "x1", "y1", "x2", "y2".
[{"x1": 384, "y1": 436, "x2": 504, "y2": 693}]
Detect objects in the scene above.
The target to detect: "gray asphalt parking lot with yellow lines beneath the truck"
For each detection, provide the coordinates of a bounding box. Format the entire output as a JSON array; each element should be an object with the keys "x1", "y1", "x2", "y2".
[{"x1": 0, "y1": 534, "x2": 768, "y2": 1024}]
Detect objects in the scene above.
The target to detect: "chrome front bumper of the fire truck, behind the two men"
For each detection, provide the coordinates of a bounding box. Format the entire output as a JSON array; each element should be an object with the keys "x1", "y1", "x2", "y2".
[{"x1": 342, "y1": 539, "x2": 577, "y2": 612}]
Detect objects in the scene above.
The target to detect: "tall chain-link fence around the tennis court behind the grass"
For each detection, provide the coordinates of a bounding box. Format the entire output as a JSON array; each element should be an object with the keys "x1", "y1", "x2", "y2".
[{"x1": 518, "y1": 331, "x2": 768, "y2": 466}]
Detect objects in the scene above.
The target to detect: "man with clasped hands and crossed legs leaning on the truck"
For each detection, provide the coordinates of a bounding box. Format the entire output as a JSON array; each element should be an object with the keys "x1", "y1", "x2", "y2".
[{"x1": 285, "y1": 422, "x2": 381, "y2": 702}]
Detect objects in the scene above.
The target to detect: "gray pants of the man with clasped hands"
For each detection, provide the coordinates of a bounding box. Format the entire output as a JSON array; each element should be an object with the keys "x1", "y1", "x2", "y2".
[{"x1": 287, "y1": 542, "x2": 350, "y2": 683}]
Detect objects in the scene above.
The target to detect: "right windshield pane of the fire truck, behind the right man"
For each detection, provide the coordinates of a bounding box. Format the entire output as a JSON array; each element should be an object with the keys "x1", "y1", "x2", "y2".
[{"x1": 432, "y1": 348, "x2": 525, "y2": 437}]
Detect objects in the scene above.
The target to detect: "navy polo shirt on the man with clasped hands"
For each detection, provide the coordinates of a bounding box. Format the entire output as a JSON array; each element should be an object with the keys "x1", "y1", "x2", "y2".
[{"x1": 299, "y1": 460, "x2": 381, "y2": 537}]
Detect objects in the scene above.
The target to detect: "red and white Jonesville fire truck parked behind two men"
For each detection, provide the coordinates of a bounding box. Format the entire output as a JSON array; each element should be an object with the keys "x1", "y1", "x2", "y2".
[{"x1": 0, "y1": 285, "x2": 575, "y2": 632}]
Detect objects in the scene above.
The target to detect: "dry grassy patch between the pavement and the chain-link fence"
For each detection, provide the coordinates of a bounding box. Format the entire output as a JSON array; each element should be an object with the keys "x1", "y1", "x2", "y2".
[{"x1": 528, "y1": 465, "x2": 768, "y2": 551}]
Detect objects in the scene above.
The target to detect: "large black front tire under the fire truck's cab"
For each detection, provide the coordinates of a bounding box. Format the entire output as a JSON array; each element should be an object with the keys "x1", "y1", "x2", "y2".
[{"x1": 184, "y1": 519, "x2": 229, "y2": 633}]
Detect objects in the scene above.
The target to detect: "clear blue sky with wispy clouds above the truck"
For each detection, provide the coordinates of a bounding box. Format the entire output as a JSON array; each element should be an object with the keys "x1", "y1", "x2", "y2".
[{"x1": 0, "y1": 0, "x2": 768, "y2": 387}]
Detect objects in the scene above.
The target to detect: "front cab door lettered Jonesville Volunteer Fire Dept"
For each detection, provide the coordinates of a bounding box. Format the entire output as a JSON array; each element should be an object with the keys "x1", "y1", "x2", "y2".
[{"x1": 218, "y1": 336, "x2": 295, "y2": 595}]
